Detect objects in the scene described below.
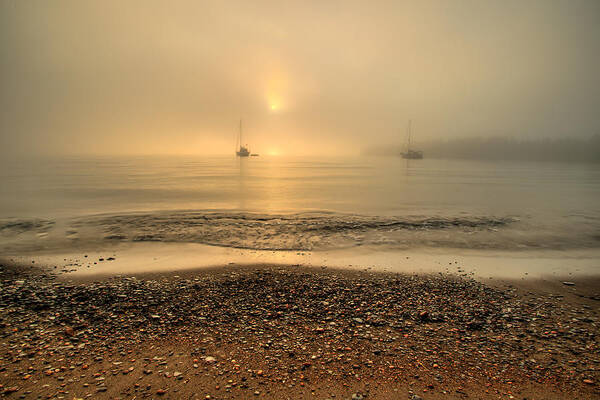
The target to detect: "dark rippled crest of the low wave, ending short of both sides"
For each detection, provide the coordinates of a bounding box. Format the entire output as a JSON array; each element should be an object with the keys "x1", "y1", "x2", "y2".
[{"x1": 74, "y1": 212, "x2": 514, "y2": 250}]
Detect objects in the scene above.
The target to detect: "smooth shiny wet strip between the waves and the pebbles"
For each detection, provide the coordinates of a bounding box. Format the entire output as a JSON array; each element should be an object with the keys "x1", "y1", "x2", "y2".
[{"x1": 0, "y1": 242, "x2": 600, "y2": 280}]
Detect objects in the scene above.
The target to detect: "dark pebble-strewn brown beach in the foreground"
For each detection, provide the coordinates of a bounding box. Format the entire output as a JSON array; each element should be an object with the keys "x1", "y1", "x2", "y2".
[{"x1": 0, "y1": 263, "x2": 600, "y2": 399}]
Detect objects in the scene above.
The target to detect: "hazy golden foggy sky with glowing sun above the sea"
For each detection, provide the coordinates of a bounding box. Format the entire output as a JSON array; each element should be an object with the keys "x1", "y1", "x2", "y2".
[{"x1": 0, "y1": 0, "x2": 600, "y2": 154}]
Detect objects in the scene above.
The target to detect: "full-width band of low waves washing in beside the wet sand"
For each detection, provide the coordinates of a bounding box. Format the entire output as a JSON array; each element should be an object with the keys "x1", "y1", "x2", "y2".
[{"x1": 0, "y1": 211, "x2": 600, "y2": 253}]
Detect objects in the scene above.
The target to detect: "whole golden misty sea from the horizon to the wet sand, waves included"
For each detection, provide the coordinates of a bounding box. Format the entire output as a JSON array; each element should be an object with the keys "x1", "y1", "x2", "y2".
[{"x1": 0, "y1": 157, "x2": 600, "y2": 254}]
